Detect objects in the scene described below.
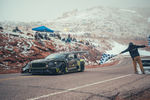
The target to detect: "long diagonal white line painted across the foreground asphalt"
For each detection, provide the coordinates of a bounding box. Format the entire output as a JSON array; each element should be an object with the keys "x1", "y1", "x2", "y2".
[{"x1": 27, "y1": 74, "x2": 133, "y2": 100}]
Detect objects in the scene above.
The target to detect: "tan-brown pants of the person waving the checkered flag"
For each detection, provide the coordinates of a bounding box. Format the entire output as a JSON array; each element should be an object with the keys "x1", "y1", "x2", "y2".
[{"x1": 133, "y1": 56, "x2": 144, "y2": 74}]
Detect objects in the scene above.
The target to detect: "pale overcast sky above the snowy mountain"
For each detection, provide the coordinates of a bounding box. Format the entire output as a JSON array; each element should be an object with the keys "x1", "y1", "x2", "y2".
[{"x1": 0, "y1": 0, "x2": 150, "y2": 21}]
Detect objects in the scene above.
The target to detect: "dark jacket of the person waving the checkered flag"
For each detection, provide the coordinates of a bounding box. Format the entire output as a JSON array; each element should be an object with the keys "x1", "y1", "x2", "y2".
[{"x1": 121, "y1": 44, "x2": 146, "y2": 59}]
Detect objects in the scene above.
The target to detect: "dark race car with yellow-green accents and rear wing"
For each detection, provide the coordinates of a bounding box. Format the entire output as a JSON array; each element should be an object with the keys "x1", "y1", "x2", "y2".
[{"x1": 21, "y1": 51, "x2": 87, "y2": 74}]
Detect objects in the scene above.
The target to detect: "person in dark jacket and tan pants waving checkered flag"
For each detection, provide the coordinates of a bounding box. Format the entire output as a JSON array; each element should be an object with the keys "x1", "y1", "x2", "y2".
[{"x1": 120, "y1": 42, "x2": 146, "y2": 74}]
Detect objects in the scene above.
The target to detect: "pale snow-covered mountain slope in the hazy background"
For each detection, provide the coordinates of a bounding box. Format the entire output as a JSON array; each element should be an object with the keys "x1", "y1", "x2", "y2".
[{"x1": 49, "y1": 7, "x2": 150, "y2": 37}]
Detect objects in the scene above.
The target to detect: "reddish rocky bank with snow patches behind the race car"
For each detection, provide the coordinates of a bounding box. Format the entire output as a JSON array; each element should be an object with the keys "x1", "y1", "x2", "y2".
[{"x1": 0, "y1": 32, "x2": 101, "y2": 73}]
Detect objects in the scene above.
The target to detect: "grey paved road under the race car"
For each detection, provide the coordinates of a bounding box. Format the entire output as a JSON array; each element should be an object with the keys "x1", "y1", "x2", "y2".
[{"x1": 0, "y1": 58, "x2": 150, "y2": 100}]
